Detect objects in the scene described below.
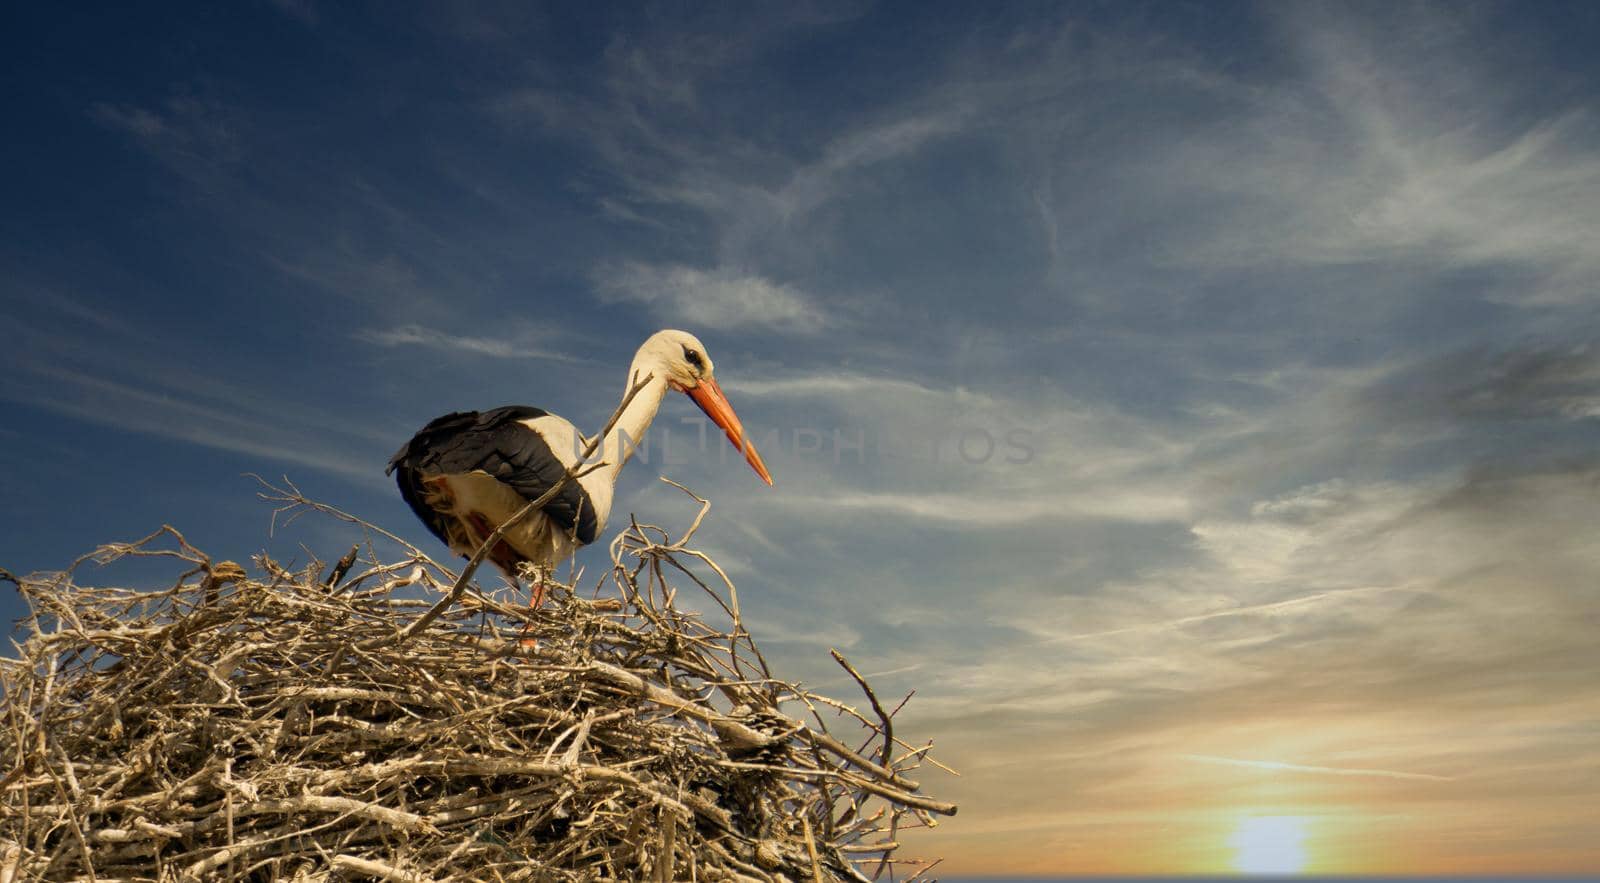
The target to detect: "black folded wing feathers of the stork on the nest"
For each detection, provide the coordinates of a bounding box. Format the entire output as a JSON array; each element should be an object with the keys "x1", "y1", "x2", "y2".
[{"x1": 384, "y1": 405, "x2": 598, "y2": 544}]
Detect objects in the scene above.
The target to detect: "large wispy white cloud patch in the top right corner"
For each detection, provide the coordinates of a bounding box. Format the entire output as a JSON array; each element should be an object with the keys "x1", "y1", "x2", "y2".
[{"x1": 1094, "y1": 6, "x2": 1600, "y2": 304}]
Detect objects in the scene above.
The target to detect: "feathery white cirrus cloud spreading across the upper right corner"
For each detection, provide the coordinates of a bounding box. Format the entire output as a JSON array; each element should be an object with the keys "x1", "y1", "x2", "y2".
[{"x1": 1030, "y1": 5, "x2": 1600, "y2": 317}]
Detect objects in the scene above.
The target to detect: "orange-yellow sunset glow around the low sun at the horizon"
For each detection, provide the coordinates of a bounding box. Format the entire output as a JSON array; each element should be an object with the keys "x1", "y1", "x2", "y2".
[{"x1": 901, "y1": 718, "x2": 1600, "y2": 877}]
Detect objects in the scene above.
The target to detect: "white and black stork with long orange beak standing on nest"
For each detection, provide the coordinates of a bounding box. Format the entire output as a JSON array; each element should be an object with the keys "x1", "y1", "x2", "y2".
[{"x1": 384, "y1": 330, "x2": 773, "y2": 606}]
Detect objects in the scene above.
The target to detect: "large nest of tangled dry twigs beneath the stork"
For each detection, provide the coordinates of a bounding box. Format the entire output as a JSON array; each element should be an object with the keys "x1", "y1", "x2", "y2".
[{"x1": 0, "y1": 491, "x2": 955, "y2": 883}]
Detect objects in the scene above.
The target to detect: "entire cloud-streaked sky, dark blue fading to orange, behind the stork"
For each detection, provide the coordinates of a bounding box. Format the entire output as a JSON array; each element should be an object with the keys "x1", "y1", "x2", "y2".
[{"x1": 0, "y1": 0, "x2": 1600, "y2": 872}]
